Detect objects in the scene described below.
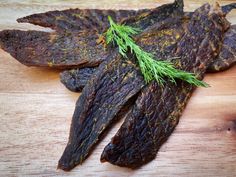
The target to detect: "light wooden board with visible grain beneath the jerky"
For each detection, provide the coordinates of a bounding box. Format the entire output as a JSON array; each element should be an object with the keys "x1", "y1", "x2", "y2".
[{"x1": 0, "y1": 0, "x2": 236, "y2": 177}]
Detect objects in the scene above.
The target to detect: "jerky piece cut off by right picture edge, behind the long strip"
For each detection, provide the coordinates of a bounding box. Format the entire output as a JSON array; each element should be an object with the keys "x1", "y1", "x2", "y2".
[{"x1": 207, "y1": 25, "x2": 236, "y2": 72}]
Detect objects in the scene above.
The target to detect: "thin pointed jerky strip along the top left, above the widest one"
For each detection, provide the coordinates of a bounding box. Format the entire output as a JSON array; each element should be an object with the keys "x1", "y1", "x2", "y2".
[{"x1": 17, "y1": 9, "x2": 151, "y2": 33}]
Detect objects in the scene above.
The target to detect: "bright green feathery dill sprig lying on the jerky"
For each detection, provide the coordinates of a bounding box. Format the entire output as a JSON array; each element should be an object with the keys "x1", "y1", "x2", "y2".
[{"x1": 105, "y1": 16, "x2": 209, "y2": 87}]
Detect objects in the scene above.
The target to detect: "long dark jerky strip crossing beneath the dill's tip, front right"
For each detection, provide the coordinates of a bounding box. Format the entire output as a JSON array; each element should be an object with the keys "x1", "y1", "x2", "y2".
[{"x1": 101, "y1": 4, "x2": 229, "y2": 168}]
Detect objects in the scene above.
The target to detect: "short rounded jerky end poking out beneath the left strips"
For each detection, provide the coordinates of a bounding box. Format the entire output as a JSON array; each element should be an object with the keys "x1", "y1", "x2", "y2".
[{"x1": 60, "y1": 68, "x2": 97, "y2": 92}]
